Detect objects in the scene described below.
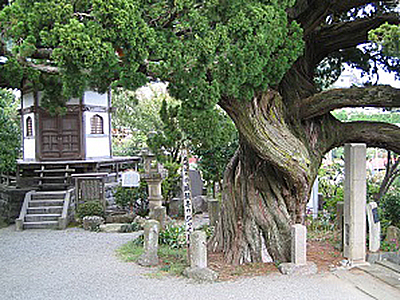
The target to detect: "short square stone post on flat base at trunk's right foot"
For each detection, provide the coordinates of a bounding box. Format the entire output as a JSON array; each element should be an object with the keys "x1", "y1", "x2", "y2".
[{"x1": 278, "y1": 224, "x2": 317, "y2": 275}]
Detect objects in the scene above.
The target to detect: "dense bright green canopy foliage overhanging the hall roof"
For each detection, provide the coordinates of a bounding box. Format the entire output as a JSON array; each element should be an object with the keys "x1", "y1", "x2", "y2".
[{"x1": 0, "y1": 0, "x2": 303, "y2": 108}]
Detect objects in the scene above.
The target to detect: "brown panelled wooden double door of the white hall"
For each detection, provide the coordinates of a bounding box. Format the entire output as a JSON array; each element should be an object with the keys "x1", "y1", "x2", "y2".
[{"x1": 39, "y1": 112, "x2": 82, "y2": 160}]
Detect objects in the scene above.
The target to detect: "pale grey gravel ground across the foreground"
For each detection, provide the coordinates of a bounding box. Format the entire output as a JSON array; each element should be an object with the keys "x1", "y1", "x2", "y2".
[{"x1": 0, "y1": 226, "x2": 372, "y2": 300}]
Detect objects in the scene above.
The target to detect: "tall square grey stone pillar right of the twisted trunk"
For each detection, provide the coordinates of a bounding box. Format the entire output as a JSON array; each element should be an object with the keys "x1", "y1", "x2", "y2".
[{"x1": 343, "y1": 144, "x2": 367, "y2": 265}]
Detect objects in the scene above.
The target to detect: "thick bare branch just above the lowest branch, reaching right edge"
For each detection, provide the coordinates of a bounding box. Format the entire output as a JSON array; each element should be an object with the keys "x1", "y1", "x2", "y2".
[{"x1": 296, "y1": 85, "x2": 400, "y2": 119}]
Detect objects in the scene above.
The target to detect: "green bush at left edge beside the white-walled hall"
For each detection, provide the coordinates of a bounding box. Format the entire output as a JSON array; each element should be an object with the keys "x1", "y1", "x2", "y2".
[{"x1": 0, "y1": 89, "x2": 21, "y2": 173}]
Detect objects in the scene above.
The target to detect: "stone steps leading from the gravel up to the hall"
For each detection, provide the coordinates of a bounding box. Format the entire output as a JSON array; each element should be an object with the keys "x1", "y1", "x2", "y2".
[{"x1": 16, "y1": 190, "x2": 73, "y2": 230}]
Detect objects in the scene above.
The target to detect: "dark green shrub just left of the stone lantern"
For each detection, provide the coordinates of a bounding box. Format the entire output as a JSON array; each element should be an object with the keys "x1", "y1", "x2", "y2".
[{"x1": 114, "y1": 180, "x2": 149, "y2": 217}]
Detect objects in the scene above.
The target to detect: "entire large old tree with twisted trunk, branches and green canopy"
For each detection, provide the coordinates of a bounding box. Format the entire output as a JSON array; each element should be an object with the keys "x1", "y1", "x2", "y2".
[{"x1": 0, "y1": 0, "x2": 400, "y2": 263}]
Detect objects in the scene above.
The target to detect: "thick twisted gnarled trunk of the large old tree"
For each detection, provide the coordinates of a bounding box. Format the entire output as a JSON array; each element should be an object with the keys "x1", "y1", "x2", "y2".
[{"x1": 210, "y1": 91, "x2": 322, "y2": 264}]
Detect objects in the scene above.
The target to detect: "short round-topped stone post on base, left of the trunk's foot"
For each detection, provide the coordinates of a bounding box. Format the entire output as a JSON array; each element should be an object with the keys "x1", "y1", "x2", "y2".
[{"x1": 183, "y1": 231, "x2": 218, "y2": 281}]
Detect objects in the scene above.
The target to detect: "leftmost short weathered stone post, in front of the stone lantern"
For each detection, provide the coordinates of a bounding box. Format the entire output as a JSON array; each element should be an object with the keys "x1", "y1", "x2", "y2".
[{"x1": 138, "y1": 220, "x2": 160, "y2": 266}]
